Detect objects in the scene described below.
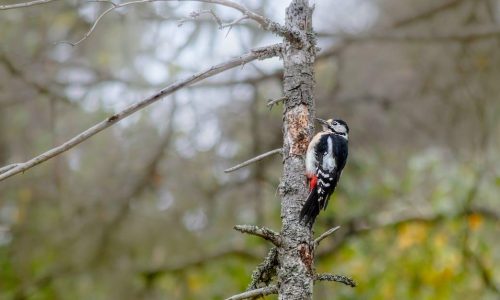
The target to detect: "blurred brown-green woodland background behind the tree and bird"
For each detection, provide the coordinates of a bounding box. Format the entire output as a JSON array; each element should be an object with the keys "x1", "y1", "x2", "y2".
[{"x1": 0, "y1": 0, "x2": 500, "y2": 300}]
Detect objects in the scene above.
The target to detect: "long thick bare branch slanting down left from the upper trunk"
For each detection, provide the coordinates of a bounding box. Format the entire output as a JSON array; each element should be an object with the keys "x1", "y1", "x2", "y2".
[{"x1": 0, "y1": 44, "x2": 282, "y2": 181}]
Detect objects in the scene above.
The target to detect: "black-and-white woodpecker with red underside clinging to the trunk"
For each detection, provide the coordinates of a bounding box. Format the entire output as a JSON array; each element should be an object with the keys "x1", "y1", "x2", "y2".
[{"x1": 300, "y1": 118, "x2": 349, "y2": 224}]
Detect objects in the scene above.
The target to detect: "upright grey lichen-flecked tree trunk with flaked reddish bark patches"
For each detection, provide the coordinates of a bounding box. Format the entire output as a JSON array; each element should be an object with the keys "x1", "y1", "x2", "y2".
[{"x1": 278, "y1": 0, "x2": 316, "y2": 300}]
